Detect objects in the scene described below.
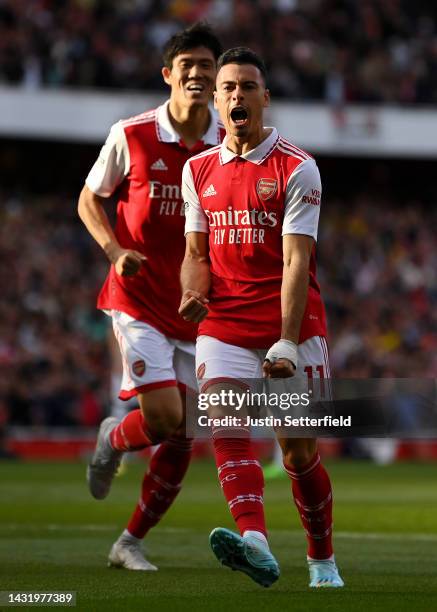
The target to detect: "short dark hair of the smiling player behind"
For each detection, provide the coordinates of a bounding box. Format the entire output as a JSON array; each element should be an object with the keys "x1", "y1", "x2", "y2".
[{"x1": 162, "y1": 21, "x2": 223, "y2": 69}]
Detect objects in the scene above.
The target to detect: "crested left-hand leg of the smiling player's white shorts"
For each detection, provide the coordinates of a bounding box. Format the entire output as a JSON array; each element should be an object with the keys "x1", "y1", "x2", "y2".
[{"x1": 111, "y1": 311, "x2": 177, "y2": 399}]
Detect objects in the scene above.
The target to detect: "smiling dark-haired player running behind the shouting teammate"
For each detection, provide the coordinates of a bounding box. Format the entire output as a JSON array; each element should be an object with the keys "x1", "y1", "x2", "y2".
[{"x1": 79, "y1": 24, "x2": 224, "y2": 570}]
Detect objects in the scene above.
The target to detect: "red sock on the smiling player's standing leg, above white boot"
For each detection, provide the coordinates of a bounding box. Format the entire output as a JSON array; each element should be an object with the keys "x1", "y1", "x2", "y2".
[{"x1": 127, "y1": 436, "x2": 193, "y2": 538}]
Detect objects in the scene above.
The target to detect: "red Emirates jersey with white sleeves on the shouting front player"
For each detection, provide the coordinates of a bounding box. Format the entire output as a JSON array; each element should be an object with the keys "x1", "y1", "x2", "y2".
[{"x1": 182, "y1": 128, "x2": 326, "y2": 349}]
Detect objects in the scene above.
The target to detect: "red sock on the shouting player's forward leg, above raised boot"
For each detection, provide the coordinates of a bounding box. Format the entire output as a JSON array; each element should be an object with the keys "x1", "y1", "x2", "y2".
[{"x1": 214, "y1": 437, "x2": 267, "y2": 536}]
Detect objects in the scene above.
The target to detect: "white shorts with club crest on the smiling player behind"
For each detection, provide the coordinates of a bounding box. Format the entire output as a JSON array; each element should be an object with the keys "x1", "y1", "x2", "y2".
[{"x1": 110, "y1": 310, "x2": 197, "y2": 400}]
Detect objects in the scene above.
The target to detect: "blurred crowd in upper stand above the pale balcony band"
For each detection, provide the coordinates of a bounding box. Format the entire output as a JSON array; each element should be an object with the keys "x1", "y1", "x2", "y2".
[{"x1": 0, "y1": 0, "x2": 437, "y2": 105}]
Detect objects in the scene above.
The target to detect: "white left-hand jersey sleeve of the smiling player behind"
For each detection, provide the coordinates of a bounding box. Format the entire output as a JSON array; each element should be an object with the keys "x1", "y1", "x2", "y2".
[{"x1": 85, "y1": 121, "x2": 130, "y2": 198}]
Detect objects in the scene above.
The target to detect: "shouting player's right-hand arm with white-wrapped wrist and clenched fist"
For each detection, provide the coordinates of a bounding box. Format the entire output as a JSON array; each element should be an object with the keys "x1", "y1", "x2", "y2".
[{"x1": 263, "y1": 159, "x2": 321, "y2": 378}]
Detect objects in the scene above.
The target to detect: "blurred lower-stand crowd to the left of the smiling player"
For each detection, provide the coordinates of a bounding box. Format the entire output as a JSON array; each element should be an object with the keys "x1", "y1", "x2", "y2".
[{"x1": 0, "y1": 196, "x2": 110, "y2": 426}]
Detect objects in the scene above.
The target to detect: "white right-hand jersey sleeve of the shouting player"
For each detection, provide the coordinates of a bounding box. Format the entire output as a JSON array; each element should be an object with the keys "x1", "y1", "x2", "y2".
[{"x1": 282, "y1": 159, "x2": 322, "y2": 240}]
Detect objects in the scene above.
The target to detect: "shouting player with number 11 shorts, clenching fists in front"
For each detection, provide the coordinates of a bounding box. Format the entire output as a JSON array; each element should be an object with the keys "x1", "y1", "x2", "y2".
[{"x1": 179, "y1": 47, "x2": 343, "y2": 587}]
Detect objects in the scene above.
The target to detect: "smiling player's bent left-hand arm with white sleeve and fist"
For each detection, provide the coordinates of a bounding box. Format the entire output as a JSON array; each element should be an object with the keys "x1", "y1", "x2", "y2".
[{"x1": 78, "y1": 123, "x2": 146, "y2": 276}]
